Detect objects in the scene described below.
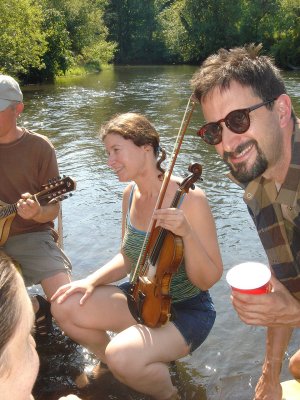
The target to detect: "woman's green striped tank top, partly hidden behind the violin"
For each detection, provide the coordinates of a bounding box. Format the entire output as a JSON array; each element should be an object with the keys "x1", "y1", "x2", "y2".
[{"x1": 122, "y1": 185, "x2": 201, "y2": 303}]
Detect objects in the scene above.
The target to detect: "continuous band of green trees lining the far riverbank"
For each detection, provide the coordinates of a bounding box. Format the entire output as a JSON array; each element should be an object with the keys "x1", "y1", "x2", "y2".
[{"x1": 0, "y1": 0, "x2": 300, "y2": 81}]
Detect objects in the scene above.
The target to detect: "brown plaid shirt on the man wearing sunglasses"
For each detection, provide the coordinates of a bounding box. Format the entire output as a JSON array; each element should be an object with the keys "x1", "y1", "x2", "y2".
[{"x1": 230, "y1": 120, "x2": 300, "y2": 299}]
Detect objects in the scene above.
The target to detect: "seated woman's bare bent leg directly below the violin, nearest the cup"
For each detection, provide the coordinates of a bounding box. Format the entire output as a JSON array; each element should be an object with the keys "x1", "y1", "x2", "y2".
[{"x1": 105, "y1": 323, "x2": 189, "y2": 400}]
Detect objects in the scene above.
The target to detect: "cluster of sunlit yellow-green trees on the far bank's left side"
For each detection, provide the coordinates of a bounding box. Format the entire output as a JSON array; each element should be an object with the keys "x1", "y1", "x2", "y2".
[{"x1": 0, "y1": 0, "x2": 116, "y2": 81}]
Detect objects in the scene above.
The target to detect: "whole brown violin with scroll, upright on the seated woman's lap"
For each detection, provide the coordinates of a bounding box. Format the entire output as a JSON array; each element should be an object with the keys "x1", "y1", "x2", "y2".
[{"x1": 127, "y1": 163, "x2": 202, "y2": 328}]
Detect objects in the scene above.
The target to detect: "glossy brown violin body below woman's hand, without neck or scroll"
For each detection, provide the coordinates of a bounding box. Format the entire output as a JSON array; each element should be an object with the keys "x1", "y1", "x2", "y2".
[{"x1": 128, "y1": 229, "x2": 183, "y2": 328}]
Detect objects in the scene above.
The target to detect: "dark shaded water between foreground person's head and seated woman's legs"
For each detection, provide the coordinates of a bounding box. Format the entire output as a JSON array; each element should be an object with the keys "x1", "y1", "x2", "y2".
[{"x1": 33, "y1": 327, "x2": 148, "y2": 400}]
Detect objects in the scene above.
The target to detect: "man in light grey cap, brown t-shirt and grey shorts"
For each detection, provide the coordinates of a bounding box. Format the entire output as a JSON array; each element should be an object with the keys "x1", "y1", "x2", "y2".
[{"x1": 0, "y1": 75, "x2": 72, "y2": 335}]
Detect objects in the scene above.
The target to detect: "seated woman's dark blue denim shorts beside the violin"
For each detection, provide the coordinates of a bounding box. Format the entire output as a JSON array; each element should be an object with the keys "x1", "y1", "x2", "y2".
[{"x1": 118, "y1": 282, "x2": 216, "y2": 353}]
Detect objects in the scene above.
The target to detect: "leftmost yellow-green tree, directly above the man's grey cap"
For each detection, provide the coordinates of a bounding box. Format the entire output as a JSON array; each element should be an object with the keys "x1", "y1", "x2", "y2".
[{"x1": 0, "y1": 0, "x2": 47, "y2": 76}]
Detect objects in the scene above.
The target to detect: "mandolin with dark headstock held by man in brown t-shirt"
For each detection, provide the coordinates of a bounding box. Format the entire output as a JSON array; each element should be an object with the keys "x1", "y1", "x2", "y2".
[{"x1": 0, "y1": 177, "x2": 76, "y2": 246}]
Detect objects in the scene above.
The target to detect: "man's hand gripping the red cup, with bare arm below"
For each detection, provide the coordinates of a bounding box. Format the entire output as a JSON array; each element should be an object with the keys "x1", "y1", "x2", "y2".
[{"x1": 232, "y1": 276, "x2": 300, "y2": 400}]
